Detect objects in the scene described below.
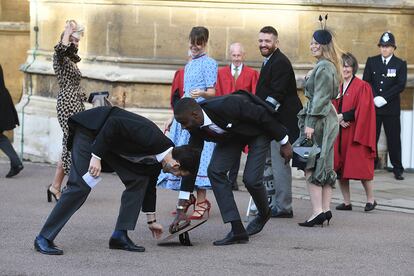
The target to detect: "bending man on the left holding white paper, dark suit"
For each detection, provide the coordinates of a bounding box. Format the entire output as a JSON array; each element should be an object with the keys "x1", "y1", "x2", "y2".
[{"x1": 34, "y1": 107, "x2": 199, "y2": 255}]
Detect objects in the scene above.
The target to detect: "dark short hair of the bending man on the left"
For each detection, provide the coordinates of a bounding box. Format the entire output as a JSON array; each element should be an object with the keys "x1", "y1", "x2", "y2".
[{"x1": 171, "y1": 145, "x2": 201, "y2": 175}]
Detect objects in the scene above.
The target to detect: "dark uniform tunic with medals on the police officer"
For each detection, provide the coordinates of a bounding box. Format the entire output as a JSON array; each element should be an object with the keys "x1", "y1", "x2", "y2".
[{"x1": 362, "y1": 55, "x2": 407, "y2": 116}]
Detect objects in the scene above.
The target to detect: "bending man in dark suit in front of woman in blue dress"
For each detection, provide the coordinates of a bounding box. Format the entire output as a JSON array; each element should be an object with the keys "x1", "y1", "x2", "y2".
[{"x1": 172, "y1": 91, "x2": 292, "y2": 245}]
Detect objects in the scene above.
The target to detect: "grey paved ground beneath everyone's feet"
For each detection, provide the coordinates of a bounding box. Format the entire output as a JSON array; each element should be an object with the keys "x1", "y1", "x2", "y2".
[{"x1": 0, "y1": 159, "x2": 414, "y2": 276}]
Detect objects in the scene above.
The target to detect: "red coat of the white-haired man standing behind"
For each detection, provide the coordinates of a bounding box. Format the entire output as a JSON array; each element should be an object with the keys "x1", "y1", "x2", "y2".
[{"x1": 216, "y1": 64, "x2": 259, "y2": 96}]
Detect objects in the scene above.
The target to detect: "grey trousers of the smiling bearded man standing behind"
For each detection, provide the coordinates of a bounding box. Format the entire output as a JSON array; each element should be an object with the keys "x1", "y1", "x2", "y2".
[{"x1": 270, "y1": 140, "x2": 292, "y2": 213}]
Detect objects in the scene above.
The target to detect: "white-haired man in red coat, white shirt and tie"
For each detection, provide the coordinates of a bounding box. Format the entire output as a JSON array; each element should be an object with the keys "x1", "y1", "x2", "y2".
[{"x1": 216, "y1": 42, "x2": 259, "y2": 190}]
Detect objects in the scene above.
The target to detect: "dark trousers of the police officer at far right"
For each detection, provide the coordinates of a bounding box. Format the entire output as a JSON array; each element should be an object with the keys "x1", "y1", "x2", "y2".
[{"x1": 376, "y1": 114, "x2": 404, "y2": 174}]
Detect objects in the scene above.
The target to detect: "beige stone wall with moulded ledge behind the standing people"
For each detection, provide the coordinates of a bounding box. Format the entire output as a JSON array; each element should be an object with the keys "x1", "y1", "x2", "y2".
[{"x1": 5, "y1": 0, "x2": 414, "y2": 167}]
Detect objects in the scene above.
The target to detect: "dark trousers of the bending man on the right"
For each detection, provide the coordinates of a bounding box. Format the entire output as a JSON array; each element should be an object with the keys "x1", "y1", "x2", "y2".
[{"x1": 207, "y1": 136, "x2": 270, "y2": 223}]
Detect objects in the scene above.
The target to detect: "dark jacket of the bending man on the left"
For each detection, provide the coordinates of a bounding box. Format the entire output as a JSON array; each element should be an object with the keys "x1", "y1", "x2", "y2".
[{"x1": 68, "y1": 107, "x2": 174, "y2": 211}]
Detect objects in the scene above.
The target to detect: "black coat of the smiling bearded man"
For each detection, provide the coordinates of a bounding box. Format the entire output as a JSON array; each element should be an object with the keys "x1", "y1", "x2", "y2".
[{"x1": 256, "y1": 49, "x2": 302, "y2": 143}]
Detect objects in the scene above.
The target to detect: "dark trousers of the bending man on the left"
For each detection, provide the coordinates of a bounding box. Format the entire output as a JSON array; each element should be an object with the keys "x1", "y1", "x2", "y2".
[{"x1": 39, "y1": 131, "x2": 149, "y2": 241}]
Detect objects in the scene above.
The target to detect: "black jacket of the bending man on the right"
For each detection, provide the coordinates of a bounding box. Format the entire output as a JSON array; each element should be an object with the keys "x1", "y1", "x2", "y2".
[{"x1": 181, "y1": 90, "x2": 287, "y2": 192}]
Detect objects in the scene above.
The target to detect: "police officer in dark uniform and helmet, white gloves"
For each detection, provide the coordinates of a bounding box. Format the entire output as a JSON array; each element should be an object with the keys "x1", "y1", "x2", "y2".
[{"x1": 363, "y1": 32, "x2": 407, "y2": 180}]
